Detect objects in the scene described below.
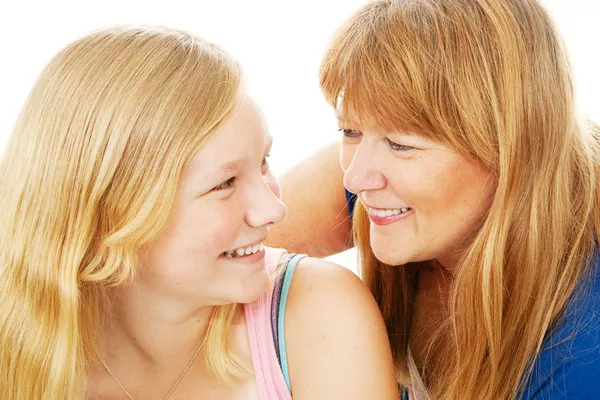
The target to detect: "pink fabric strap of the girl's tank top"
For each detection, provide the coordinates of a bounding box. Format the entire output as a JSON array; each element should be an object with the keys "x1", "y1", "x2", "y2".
[{"x1": 244, "y1": 248, "x2": 292, "y2": 400}]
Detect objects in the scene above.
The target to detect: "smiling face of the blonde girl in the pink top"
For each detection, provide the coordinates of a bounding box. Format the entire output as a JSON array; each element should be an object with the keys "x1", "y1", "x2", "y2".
[{"x1": 139, "y1": 94, "x2": 286, "y2": 304}]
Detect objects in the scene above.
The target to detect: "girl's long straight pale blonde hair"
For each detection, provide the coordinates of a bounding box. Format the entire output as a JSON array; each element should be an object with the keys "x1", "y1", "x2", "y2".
[{"x1": 0, "y1": 27, "x2": 243, "y2": 400}]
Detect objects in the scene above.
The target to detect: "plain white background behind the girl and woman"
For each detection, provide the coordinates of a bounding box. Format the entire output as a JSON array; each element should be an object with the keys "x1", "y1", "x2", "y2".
[{"x1": 0, "y1": 0, "x2": 600, "y2": 270}]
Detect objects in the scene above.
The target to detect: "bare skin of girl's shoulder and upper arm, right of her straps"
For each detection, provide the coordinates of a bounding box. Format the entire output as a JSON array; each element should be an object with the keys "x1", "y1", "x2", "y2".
[{"x1": 285, "y1": 257, "x2": 398, "y2": 400}]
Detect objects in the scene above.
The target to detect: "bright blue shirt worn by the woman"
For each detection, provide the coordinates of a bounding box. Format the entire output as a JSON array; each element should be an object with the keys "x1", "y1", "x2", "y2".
[{"x1": 346, "y1": 191, "x2": 600, "y2": 400}]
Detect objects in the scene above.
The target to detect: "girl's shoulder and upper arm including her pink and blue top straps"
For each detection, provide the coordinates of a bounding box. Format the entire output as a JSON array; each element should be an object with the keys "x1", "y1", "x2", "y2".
[{"x1": 245, "y1": 249, "x2": 398, "y2": 400}]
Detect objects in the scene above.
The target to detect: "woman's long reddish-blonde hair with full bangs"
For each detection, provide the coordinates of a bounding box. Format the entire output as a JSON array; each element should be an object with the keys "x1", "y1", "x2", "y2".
[{"x1": 321, "y1": 0, "x2": 600, "y2": 399}]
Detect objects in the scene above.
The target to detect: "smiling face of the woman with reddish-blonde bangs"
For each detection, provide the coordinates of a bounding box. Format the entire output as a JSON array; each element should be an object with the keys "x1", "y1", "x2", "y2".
[{"x1": 340, "y1": 120, "x2": 495, "y2": 268}]
